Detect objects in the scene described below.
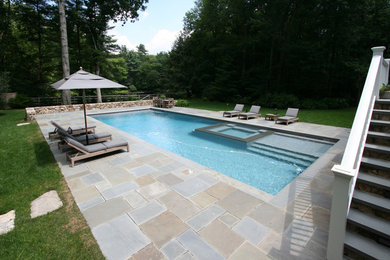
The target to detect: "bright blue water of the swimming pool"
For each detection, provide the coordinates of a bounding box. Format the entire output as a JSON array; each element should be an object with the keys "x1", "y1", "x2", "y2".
[{"x1": 94, "y1": 110, "x2": 332, "y2": 195}]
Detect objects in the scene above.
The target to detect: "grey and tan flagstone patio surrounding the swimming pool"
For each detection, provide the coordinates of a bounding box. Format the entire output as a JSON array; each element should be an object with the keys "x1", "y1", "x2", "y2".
[{"x1": 37, "y1": 108, "x2": 348, "y2": 259}]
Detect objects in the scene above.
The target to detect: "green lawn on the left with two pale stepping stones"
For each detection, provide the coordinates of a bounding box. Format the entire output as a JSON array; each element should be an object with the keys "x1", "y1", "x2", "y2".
[{"x1": 0, "y1": 110, "x2": 104, "y2": 259}]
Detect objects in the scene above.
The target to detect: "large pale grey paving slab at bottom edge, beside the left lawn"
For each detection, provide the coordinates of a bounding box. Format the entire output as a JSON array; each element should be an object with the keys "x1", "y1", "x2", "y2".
[{"x1": 92, "y1": 215, "x2": 150, "y2": 259}]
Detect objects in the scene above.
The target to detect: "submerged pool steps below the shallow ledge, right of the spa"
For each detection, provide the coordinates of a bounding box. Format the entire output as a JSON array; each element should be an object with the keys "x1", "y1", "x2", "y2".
[{"x1": 248, "y1": 144, "x2": 317, "y2": 168}]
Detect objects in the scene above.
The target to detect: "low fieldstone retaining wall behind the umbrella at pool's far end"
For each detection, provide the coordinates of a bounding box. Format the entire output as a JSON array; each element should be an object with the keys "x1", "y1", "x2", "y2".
[{"x1": 25, "y1": 100, "x2": 153, "y2": 120}]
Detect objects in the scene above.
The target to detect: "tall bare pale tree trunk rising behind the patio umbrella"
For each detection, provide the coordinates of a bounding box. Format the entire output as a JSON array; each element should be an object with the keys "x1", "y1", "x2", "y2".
[{"x1": 58, "y1": 0, "x2": 71, "y2": 105}]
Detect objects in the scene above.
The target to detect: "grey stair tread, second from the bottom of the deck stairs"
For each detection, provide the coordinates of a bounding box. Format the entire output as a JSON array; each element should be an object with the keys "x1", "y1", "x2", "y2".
[{"x1": 347, "y1": 208, "x2": 390, "y2": 239}]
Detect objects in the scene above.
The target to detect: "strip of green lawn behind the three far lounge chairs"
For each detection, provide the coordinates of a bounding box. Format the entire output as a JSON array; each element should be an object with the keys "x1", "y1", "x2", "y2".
[{"x1": 189, "y1": 99, "x2": 356, "y2": 128}]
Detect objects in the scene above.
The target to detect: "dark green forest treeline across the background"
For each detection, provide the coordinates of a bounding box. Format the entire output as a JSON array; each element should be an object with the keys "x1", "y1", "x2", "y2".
[{"x1": 0, "y1": 0, "x2": 390, "y2": 107}]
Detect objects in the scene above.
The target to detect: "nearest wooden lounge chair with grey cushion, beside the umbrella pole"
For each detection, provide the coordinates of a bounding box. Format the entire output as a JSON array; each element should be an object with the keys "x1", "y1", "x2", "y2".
[{"x1": 64, "y1": 137, "x2": 130, "y2": 167}]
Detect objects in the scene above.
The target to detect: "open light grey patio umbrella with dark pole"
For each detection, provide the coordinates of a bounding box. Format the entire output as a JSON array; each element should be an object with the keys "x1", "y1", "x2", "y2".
[{"x1": 50, "y1": 67, "x2": 126, "y2": 144}]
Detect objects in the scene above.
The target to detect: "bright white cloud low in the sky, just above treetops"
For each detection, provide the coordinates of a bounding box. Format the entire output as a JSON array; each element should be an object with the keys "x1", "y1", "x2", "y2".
[{"x1": 145, "y1": 29, "x2": 179, "y2": 54}]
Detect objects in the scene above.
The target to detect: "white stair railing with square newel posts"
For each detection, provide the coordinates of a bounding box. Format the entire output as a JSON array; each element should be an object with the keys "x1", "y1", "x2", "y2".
[{"x1": 327, "y1": 46, "x2": 389, "y2": 260}]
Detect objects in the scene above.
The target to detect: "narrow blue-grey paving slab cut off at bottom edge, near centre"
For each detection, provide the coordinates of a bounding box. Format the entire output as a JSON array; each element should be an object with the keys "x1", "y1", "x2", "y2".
[{"x1": 178, "y1": 230, "x2": 225, "y2": 260}]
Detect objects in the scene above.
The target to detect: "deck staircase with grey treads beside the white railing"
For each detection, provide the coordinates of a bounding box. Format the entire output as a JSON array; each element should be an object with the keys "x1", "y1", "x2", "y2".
[{"x1": 344, "y1": 99, "x2": 390, "y2": 259}]
